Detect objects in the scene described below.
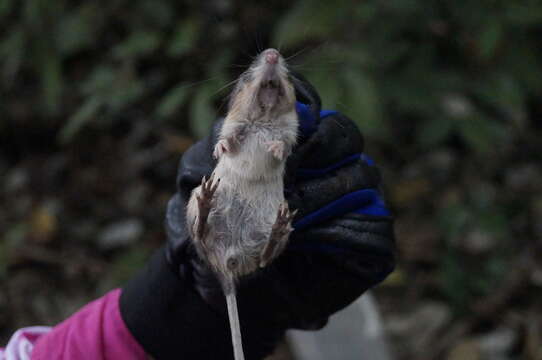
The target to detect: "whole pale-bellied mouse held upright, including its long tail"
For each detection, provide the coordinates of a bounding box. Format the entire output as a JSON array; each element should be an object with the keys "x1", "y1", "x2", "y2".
[{"x1": 186, "y1": 48, "x2": 299, "y2": 360}]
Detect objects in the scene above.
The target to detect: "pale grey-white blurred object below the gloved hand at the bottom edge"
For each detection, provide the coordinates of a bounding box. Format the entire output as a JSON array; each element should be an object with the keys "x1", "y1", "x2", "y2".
[{"x1": 288, "y1": 293, "x2": 393, "y2": 360}]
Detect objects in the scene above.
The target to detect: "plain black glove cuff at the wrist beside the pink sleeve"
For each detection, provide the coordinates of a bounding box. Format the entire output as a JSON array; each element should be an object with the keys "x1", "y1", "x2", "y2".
[{"x1": 120, "y1": 248, "x2": 236, "y2": 360}]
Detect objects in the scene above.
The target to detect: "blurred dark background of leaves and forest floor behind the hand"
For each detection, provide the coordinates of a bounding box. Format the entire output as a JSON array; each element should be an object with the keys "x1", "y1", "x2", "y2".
[{"x1": 0, "y1": 0, "x2": 542, "y2": 360}]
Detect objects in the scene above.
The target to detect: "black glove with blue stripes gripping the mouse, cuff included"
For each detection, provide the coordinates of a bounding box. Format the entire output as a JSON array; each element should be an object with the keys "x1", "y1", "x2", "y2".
[{"x1": 121, "y1": 74, "x2": 394, "y2": 359}]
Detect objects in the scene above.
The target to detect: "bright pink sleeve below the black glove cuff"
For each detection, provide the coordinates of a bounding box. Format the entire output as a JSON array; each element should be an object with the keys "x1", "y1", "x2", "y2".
[{"x1": 31, "y1": 289, "x2": 147, "y2": 360}]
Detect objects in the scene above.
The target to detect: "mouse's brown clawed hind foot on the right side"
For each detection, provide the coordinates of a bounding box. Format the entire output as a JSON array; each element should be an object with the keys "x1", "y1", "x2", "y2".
[{"x1": 260, "y1": 203, "x2": 297, "y2": 268}]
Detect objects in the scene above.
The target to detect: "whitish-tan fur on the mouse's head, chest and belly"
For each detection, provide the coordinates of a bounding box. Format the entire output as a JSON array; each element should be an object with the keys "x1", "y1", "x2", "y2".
[{"x1": 187, "y1": 49, "x2": 298, "y2": 278}]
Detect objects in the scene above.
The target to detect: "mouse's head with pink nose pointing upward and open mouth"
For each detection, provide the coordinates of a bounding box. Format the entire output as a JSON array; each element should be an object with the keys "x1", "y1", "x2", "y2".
[{"x1": 228, "y1": 49, "x2": 295, "y2": 120}]
